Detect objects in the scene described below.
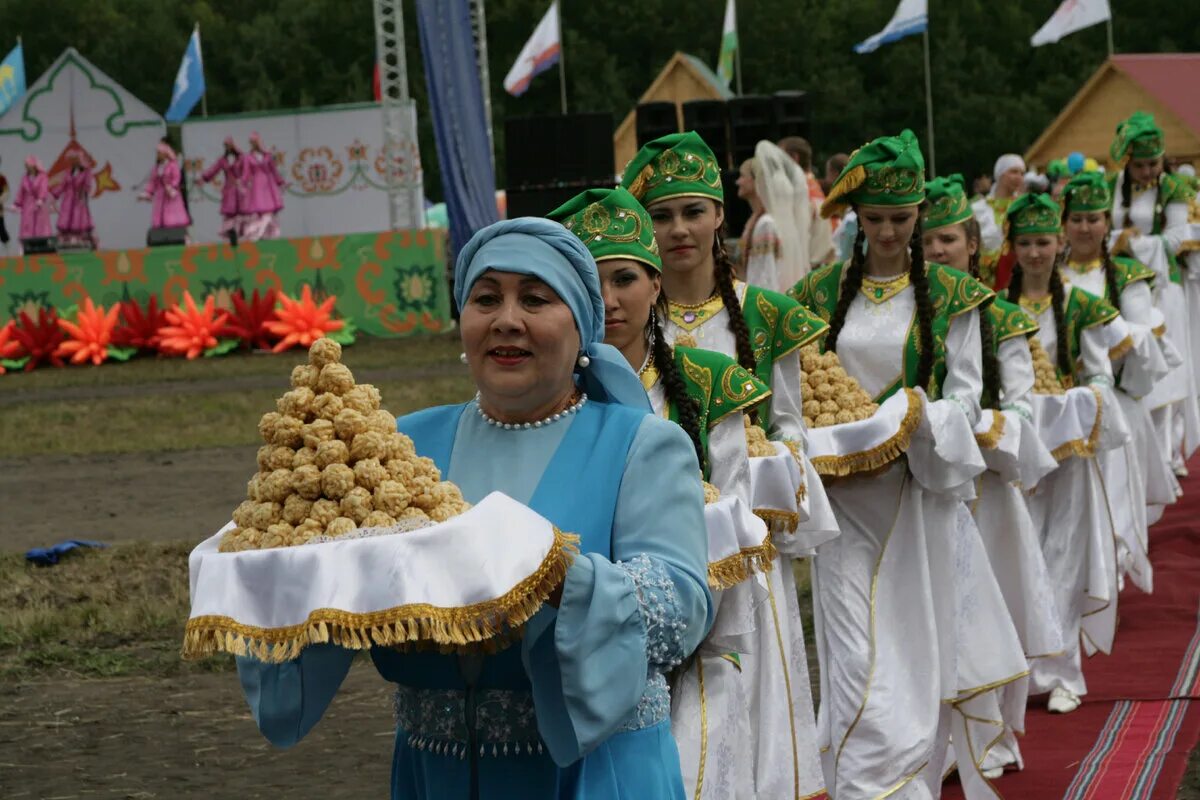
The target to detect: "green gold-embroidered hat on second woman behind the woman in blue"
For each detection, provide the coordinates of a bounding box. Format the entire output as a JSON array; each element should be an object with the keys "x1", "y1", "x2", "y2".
[{"x1": 620, "y1": 131, "x2": 725, "y2": 207}]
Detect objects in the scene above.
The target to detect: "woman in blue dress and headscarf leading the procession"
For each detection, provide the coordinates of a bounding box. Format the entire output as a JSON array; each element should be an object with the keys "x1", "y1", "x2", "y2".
[{"x1": 238, "y1": 218, "x2": 713, "y2": 800}]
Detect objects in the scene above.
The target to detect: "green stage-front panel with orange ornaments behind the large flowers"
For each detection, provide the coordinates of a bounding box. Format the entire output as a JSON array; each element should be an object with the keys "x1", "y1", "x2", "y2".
[{"x1": 0, "y1": 230, "x2": 451, "y2": 336}]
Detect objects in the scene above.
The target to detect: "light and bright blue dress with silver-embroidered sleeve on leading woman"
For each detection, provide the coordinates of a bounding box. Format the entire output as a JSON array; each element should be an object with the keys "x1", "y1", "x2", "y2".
[{"x1": 238, "y1": 401, "x2": 713, "y2": 800}]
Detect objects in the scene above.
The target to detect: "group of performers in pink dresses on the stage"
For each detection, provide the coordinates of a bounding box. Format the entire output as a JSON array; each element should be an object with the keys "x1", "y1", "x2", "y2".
[{"x1": 0, "y1": 133, "x2": 287, "y2": 255}]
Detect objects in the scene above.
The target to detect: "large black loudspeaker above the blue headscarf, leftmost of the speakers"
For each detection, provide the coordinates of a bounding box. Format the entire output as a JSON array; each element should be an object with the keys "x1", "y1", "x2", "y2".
[{"x1": 504, "y1": 113, "x2": 616, "y2": 189}]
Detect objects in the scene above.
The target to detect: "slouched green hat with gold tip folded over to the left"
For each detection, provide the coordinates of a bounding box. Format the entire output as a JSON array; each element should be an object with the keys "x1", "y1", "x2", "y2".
[{"x1": 821, "y1": 128, "x2": 925, "y2": 218}]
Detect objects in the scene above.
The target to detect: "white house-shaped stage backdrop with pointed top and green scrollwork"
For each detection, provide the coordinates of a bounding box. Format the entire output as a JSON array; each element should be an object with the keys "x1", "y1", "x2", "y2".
[{"x1": 0, "y1": 48, "x2": 166, "y2": 248}]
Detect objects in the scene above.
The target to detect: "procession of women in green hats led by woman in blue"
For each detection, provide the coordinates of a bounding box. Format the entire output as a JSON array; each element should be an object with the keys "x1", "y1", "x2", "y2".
[{"x1": 226, "y1": 114, "x2": 1200, "y2": 800}]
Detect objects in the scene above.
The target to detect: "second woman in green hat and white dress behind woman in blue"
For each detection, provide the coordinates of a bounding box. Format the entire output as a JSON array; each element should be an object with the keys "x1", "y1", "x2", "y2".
[{"x1": 622, "y1": 131, "x2": 836, "y2": 800}]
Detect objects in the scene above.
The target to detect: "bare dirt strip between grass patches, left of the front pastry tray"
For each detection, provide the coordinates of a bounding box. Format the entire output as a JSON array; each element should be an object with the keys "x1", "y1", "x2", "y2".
[{"x1": 0, "y1": 447, "x2": 254, "y2": 549}]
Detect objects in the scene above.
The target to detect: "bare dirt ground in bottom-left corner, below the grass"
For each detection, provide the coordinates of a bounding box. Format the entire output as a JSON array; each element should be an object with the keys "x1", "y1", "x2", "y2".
[{"x1": 0, "y1": 663, "x2": 394, "y2": 800}]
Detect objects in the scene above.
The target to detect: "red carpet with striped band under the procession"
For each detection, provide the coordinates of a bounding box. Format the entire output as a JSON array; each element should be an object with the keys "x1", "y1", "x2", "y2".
[{"x1": 942, "y1": 457, "x2": 1200, "y2": 800}]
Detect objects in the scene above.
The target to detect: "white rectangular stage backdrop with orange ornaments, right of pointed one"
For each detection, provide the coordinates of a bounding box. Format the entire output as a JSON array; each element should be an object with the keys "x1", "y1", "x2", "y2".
[{"x1": 177, "y1": 103, "x2": 424, "y2": 241}]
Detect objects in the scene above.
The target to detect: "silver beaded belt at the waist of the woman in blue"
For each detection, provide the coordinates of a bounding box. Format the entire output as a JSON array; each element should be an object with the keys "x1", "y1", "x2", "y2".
[{"x1": 392, "y1": 672, "x2": 671, "y2": 758}]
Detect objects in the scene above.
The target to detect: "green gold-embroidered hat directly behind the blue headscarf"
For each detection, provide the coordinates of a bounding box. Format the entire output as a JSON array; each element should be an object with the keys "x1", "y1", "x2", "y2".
[{"x1": 546, "y1": 186, "x2": 662, "y2": 272}]
